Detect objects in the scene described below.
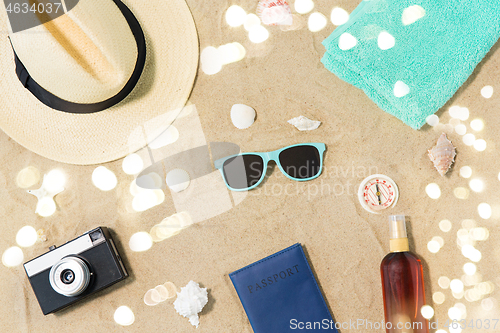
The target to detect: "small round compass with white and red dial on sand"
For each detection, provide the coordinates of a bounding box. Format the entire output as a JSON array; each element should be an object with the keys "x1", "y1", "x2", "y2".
[{"x1": 358, "y1": 175, "x2": 399, "y2": 214}]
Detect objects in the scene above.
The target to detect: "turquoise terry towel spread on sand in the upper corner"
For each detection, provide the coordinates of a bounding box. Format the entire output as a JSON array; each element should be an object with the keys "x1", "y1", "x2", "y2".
[{"x1": 322, "y1": 0, "x2": 500, "y2": 129}]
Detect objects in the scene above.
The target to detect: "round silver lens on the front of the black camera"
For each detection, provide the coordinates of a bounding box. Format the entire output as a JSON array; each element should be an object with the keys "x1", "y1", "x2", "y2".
[{"x1": 49, "y1": 256, "x2": 91, "y2": 297}]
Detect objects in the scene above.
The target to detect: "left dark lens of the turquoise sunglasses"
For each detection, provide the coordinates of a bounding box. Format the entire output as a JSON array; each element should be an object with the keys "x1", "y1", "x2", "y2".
[{"x1": 222, "y1": 155, "x2": 264, "y2": 190}]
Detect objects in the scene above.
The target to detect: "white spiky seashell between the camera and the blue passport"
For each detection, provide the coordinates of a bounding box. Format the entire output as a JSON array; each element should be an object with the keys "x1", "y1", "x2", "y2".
[{"x1": 174, "y1": 281, "x2": 208, "y2": 327}]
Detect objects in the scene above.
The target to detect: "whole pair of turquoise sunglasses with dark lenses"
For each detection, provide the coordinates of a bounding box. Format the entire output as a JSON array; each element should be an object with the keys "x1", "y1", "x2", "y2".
[{"x1": 214, "y1": 143, "x2": 326, "y2": 191}]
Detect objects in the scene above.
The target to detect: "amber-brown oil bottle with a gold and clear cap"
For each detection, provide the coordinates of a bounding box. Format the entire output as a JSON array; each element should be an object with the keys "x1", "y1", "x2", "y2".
[{"x1": 380, "y1": 215, "x2": 429, "y2": 333}]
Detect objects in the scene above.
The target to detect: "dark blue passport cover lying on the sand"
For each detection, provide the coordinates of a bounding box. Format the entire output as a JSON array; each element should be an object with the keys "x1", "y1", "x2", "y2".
[{"x1": 229, "y1": 243, "x2": 337, "y2": 333}]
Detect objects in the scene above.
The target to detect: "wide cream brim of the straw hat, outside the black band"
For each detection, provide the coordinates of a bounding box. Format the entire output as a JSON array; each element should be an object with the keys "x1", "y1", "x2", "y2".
[{"x1": 0, "y1": 0, "x2": 199, "y2": 165}]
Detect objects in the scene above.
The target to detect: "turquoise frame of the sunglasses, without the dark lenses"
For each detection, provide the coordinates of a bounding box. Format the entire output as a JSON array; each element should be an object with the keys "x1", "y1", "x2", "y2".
[{"x1": 214, "y1": 142, "x2": 326, "y2": 192}]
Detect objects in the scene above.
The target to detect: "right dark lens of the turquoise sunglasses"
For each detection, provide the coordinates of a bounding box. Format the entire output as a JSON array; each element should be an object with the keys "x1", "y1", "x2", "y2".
[{"x1": 279, "y1": 146, "x2": 321, "y2": 179}]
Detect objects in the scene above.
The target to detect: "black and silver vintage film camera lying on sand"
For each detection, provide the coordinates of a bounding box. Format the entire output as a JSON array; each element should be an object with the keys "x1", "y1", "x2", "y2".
[{"x1": 24, "y1": 227, "x2": 128, "y2": 315}]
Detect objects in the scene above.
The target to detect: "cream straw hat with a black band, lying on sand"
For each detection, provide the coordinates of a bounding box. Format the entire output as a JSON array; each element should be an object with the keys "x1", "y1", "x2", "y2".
[{"x1": 0, "y1": 0, "x2": 199, "y2": 164}]
